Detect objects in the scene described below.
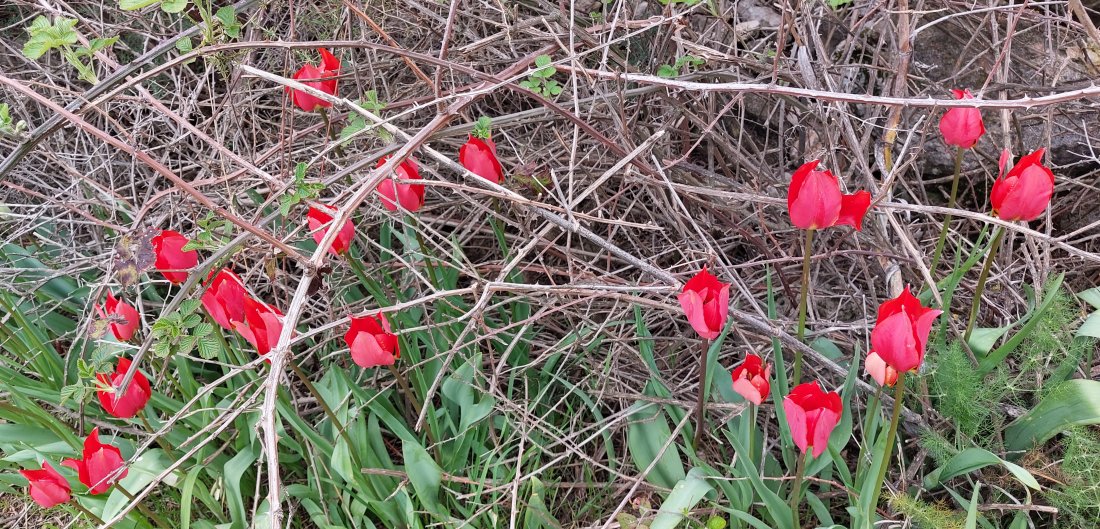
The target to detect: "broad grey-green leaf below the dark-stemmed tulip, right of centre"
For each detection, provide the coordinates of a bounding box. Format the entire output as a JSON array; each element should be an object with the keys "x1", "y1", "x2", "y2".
[{"x1": 626, "y1": 403, "x2": 688, "y2": 488}]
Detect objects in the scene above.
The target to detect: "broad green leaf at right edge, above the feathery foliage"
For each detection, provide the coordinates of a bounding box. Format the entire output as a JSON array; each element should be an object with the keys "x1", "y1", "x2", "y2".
[{"x1": 1004, "y1": 379, "x2": 1100, "y2": 451}]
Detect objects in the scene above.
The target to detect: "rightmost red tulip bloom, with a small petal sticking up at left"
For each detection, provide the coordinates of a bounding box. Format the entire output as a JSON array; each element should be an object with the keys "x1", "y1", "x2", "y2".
[{"x1": 989, "y1": 148, "x2": 1054, "y2": 221}]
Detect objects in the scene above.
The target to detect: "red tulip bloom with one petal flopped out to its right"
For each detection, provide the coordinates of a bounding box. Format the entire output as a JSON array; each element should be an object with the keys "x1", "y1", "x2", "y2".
[{"x1": 787, "y1": 159, "x2": 871, "y2": 231}]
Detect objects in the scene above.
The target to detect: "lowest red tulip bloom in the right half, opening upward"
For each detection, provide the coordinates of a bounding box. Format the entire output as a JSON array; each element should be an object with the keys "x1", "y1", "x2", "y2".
[{"x1": 783, "y1": 382, "x2": 844, "y2": 458}]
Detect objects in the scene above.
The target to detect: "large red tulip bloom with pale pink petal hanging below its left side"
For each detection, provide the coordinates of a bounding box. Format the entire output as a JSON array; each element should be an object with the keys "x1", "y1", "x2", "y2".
[{"x1": 871, "y1": 286, "x2": 943, "y2": 373}]
